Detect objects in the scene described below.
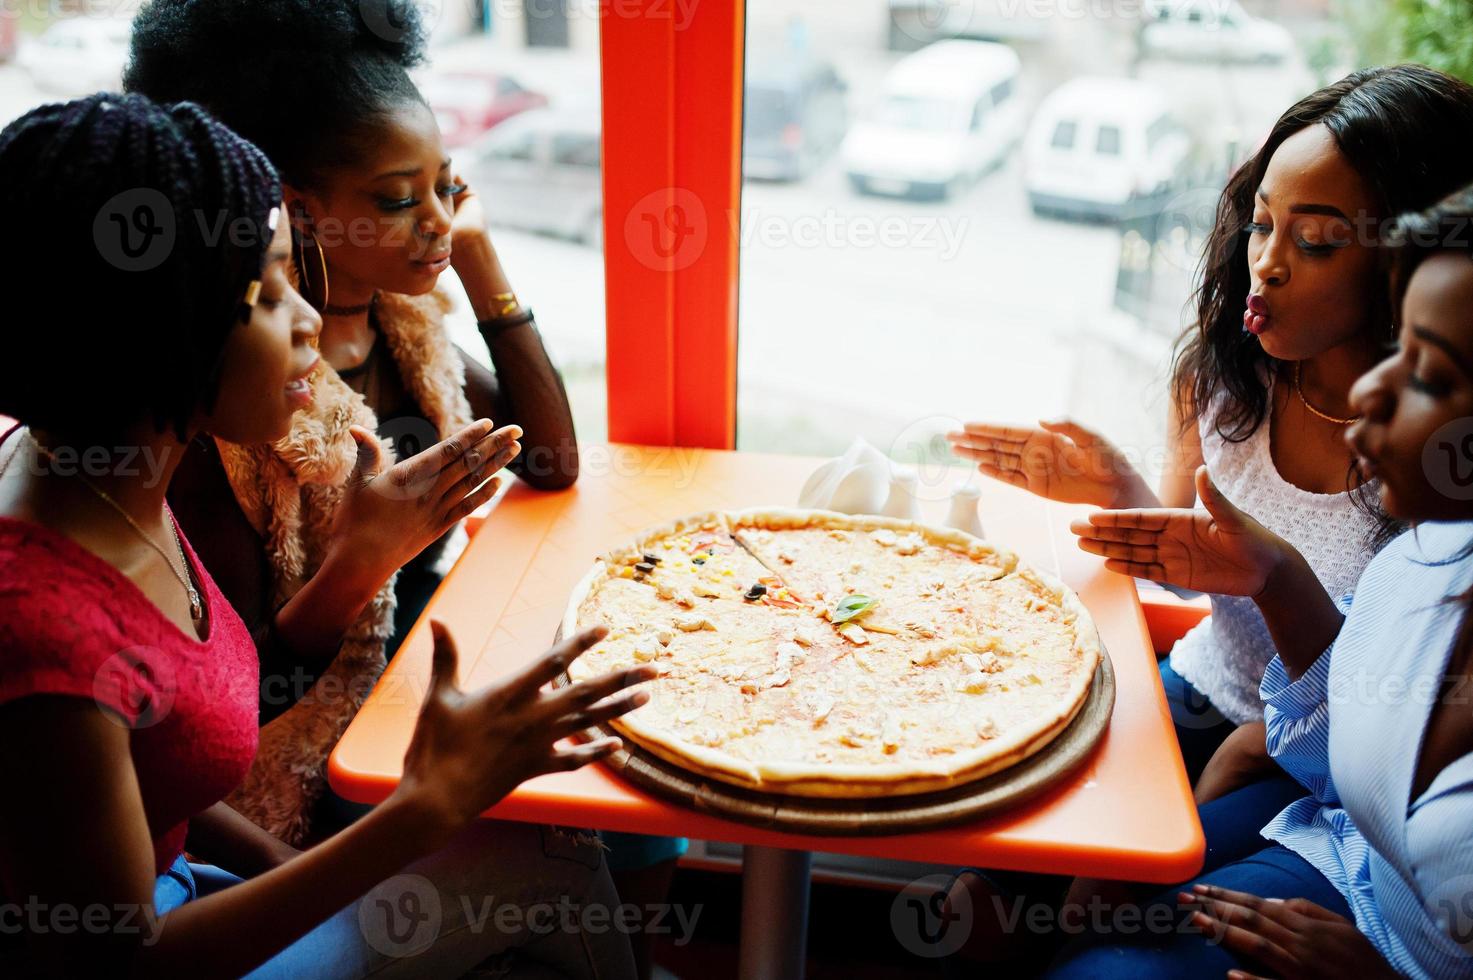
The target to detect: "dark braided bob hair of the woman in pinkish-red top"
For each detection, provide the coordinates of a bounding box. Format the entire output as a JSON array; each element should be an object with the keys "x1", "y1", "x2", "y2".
[{"x1": 0, "y1": 93, "x2": 281, "y2": 439}]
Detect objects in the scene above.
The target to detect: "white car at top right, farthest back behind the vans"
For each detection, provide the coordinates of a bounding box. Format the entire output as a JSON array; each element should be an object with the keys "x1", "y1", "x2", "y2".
[{"x1": 1140, "y1": 0, "x2": 1295, "y2": 63}]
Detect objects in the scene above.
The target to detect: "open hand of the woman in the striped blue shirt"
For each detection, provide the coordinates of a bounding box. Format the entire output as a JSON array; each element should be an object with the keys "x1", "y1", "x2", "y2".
[{"x1": 1069, "y1": 466, "x2": 1290, "y2": 595}]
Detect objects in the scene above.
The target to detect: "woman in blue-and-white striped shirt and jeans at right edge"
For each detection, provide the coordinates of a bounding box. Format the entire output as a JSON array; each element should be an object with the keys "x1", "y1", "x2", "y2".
[{"x1": 1052, "y1": 189, "x2": 1473, "y2": 980}]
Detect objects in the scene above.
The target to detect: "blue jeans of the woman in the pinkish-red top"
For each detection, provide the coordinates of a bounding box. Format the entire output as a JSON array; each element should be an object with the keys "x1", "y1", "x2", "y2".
[{"x1": 153, "y1": 819, "x2": 639, "y2": 980}]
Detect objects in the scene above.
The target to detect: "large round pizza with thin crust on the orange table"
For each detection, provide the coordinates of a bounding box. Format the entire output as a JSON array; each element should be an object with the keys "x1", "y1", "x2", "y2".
[{"x1": 563, "y1": 510, "x2": 1100, "y2": 797}]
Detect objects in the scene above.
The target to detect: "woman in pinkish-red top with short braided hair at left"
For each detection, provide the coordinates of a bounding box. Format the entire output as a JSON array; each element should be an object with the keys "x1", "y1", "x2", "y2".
[{"x1": 0, "y1": 94, "x2": 651, "y2": 977}]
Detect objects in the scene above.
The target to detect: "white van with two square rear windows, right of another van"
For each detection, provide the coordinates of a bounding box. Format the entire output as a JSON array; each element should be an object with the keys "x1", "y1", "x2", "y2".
[{"x1": 1024, "y1": 77, "x2": 1192, "y2": 220}]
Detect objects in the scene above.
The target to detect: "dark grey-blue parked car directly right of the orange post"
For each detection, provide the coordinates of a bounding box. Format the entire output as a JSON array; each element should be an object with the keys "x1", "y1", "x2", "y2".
[{"x1": 741, "y1": 57, "x2": 848, "y2": 180}]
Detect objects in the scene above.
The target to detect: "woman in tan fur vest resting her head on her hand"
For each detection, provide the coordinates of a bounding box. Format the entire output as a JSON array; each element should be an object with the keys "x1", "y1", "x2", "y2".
[{"x1": 125, "y1": 0, "x2": 577, "y2": 844}]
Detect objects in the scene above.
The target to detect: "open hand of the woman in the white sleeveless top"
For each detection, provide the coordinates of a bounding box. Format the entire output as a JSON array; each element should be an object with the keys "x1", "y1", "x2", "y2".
[{"x1": 946, "y1": 420, "x2": 1153, "y2": 507}]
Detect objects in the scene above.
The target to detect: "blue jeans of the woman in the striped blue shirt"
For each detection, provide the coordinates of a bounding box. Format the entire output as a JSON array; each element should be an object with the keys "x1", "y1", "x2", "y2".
[{"x1": 1044, "y1": 842, "x2": 1351, "y2": 980}]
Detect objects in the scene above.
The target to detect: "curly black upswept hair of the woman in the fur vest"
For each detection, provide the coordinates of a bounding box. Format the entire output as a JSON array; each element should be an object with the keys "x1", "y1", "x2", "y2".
[{"x1": 122, "y1": 0, "x2": 426, "y2": 189}]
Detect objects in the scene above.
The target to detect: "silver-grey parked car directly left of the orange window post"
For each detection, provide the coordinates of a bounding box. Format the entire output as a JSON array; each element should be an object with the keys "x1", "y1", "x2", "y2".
[{"x1": 464, "y1": 106, "x2": 604, "y2": 246}]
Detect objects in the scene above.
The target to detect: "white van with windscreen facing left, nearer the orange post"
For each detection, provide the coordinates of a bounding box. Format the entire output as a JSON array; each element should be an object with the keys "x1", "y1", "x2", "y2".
[{"x1": 840, "y1": 40, "x2": 1024, "y2": 197}]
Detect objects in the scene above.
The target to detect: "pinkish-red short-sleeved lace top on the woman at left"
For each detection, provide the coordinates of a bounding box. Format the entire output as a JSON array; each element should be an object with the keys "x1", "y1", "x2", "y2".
[{"x1": 0, "y1": 427, "x2": 258, "y2": 874}]
